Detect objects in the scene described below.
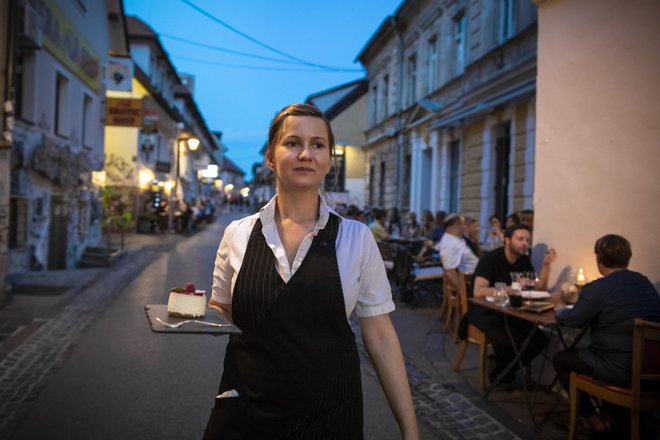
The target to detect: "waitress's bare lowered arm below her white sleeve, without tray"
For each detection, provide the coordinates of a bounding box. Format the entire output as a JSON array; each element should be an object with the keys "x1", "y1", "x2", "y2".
[{"x1": 360, "y1": 315, "x2": 419, "y2": 440}]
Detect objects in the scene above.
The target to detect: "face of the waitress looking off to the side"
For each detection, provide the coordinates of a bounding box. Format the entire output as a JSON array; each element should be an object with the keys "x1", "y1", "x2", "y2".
[{"x1": 268, "y1": 116, "x2": 330, "y2": 189}]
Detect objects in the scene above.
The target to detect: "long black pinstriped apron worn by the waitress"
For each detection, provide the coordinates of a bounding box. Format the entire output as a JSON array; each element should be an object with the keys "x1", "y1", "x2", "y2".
[{"x1": 204, "y1": 215, "x2": 363, "y2": 440}]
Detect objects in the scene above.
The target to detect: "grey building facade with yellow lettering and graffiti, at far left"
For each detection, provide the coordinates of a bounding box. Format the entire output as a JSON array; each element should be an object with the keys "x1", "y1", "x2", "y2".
[{"x1": 2, "y1": 0, "x2": 128, "y2": 274}]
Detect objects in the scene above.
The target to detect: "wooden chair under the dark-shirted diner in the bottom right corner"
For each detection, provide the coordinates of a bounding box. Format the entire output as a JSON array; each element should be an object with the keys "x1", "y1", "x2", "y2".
[{"x1": 568, "y1": 319, "x2": 660, "y2": 440}]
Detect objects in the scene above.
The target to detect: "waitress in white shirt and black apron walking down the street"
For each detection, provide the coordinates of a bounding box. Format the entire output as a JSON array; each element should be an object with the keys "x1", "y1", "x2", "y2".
[{"x1": 204, "y1": 104, "x2": 419, "y2": 440}]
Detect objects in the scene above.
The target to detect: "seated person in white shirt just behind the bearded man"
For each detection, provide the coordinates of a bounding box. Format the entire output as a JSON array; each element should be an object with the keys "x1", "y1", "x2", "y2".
[{"x1": 437, "y1": 214, "x2": 479, "y2": 289}]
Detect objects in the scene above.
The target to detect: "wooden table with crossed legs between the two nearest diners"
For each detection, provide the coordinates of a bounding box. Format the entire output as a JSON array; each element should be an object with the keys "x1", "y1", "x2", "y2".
[{"x1": 469, "y1": 297, "x2": 586, "y2": 430}]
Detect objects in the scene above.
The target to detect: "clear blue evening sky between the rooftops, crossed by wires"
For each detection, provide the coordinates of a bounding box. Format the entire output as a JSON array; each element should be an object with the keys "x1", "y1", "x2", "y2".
[{"x1": 124, "y1": 0, "x2": 401, "y2": 178}]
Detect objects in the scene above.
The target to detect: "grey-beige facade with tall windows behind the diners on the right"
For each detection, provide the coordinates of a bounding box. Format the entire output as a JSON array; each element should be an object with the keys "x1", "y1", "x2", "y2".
[{"x1": 357, "y1": 0, "x2": 537, "y2": 234}]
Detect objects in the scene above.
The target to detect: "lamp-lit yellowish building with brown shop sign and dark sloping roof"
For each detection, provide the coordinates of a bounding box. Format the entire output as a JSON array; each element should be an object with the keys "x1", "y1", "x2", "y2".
[{"x1": 103, "y1": 17, "x2": 222, "y2": 232}]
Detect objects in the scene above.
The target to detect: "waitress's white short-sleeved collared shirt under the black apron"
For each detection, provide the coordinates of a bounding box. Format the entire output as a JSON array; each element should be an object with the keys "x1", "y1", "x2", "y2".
[{"x1": 211, "y1": 196, "x2": 394, "y2": 318}]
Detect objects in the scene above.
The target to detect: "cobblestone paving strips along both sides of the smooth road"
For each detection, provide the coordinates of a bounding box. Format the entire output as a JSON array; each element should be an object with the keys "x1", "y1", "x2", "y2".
[{"x1": 0, "y1": 214, "x2": 568, "y2": 440}]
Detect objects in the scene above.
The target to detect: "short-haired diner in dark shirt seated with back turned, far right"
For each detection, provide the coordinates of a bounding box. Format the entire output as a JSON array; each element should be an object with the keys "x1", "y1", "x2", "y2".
[{"x1": 551, "y1": 234, "x2": 660, "y2": 431}]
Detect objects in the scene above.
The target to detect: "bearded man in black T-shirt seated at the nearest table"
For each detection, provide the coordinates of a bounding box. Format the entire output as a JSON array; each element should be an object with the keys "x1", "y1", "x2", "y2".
[{"x1": 469, "y1": 224, "x2": 557, "y2": 388}]
